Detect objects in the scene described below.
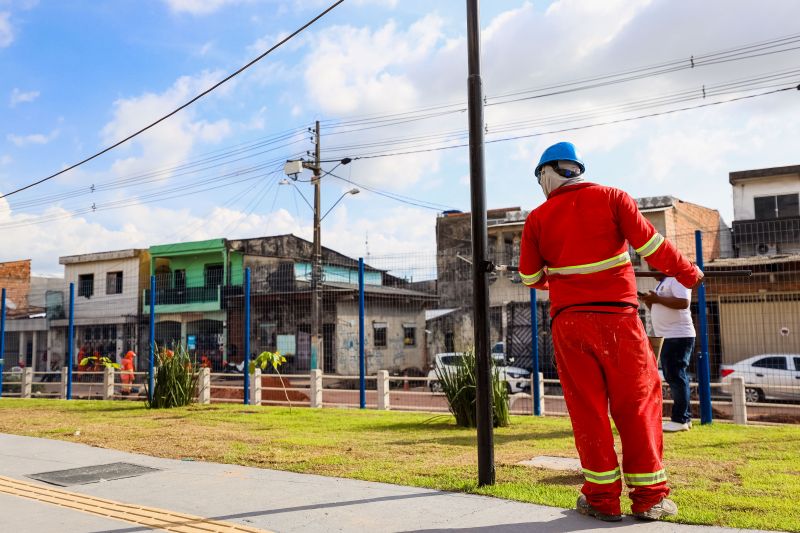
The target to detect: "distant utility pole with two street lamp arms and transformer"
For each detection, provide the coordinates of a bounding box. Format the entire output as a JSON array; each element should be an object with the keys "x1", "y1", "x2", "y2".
[{"x1": 279, "y1": 145, "x2": 360, "y2": 372}]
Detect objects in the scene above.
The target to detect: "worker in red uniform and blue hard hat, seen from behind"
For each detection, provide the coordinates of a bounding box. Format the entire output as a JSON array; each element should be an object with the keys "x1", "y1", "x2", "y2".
[{"x1": 519, "y1": 142, "x2": 703, "y2": 521}]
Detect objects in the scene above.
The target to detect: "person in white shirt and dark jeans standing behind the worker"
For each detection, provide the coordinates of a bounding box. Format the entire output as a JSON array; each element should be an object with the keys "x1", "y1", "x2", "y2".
[{"x1": 640, "y1": 276, "x2": 696, "y2": 431}]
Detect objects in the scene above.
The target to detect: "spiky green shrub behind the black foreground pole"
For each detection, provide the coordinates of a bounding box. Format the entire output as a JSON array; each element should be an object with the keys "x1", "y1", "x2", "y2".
[{"x1": 436, "y1": 348, "x2": 510, "y2": 427}]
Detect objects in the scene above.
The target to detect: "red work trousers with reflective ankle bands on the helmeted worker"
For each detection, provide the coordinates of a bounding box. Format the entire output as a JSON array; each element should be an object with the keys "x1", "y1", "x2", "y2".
[{"x1": 552, "y1": 309, "x2": 669, "y2": 514}]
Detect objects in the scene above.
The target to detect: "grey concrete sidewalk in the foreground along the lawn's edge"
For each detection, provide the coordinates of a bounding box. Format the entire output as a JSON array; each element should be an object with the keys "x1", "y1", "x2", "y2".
[{"x1": 0, "y1": 434, "x2": 768, "y2": 533}]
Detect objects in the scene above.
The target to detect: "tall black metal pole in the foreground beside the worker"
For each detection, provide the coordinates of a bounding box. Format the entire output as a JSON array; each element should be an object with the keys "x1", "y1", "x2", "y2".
[{"x1": 467, "y1": 0, "x2": 495, "y2": 486}]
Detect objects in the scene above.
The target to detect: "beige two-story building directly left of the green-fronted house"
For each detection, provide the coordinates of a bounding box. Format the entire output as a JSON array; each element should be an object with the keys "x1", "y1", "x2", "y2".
[{"x1": 47, "y1": 248, "x2": 149, "y2": 365}]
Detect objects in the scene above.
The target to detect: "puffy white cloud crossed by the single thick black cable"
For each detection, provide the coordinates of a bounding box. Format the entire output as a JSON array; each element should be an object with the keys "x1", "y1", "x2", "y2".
[{"x1": 102, "y1": 72, "x2": 232, "y2": 179}]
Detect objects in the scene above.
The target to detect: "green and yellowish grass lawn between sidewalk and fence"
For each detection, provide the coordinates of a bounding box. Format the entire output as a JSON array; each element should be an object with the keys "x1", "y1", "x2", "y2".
[{"x1": 0, "y1": 399, "x2": 800, "y2": 531}]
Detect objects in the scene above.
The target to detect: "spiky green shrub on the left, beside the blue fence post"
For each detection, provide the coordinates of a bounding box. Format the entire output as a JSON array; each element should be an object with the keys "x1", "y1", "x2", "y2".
[{"x1": 145, "y1": 345, "x2": 197, "y2": 409}]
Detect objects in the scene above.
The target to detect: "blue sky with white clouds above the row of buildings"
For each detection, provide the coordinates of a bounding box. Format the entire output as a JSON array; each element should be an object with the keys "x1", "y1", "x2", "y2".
[{"x1": 0, "y1": 0, "x2": 800, "y2": 273}]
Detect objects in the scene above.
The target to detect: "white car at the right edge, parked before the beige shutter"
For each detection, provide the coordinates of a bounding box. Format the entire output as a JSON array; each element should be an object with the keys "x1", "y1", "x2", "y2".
[{"x1": 720, "y1": 353, "x2": 800, "y2": 403}]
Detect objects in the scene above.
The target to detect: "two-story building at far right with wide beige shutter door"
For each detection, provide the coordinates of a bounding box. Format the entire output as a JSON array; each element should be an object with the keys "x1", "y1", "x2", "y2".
[{"x1": 705, "y1": 165, "x2": 800, "y2": 370}]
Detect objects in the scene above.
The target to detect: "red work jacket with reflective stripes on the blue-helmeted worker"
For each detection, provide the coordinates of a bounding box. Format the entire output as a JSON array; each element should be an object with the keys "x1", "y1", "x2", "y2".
[{"x1": 519, "y1": 183, "x2": 700, "y2": 316}]
